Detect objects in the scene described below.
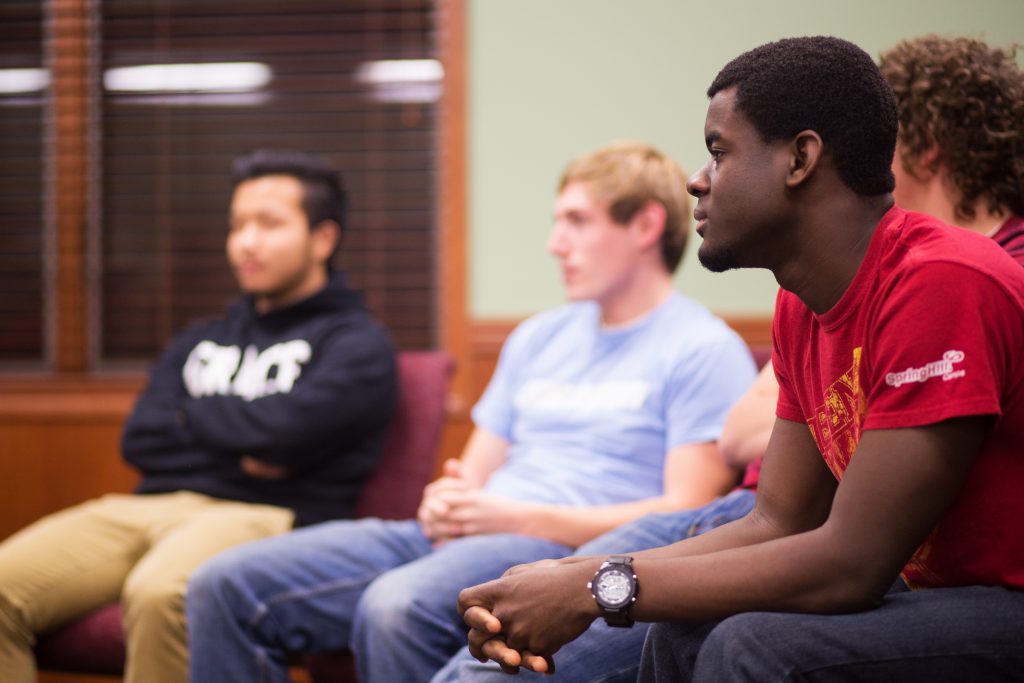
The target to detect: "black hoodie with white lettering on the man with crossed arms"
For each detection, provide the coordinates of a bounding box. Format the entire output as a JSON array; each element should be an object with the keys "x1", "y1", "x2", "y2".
[{"x1": 122, "y1": 273, "x2": 396, "y2": 524}]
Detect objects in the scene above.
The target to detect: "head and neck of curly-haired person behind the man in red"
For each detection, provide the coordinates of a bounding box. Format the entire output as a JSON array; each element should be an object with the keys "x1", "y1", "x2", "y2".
[{"x1": 880, "y1": 35, "x2": 1024, "y2": 265}]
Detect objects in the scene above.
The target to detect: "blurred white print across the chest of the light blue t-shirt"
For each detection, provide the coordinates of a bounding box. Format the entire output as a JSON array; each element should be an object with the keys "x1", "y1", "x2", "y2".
[{"x1": 514, "y1": 380, "x2": 651, "y2": 415}]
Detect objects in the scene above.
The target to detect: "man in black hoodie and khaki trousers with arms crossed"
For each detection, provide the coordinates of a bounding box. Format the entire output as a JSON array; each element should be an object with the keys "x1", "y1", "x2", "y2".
[{"x1": 0, "y1": 152, "x2": 395, "y2": 683}]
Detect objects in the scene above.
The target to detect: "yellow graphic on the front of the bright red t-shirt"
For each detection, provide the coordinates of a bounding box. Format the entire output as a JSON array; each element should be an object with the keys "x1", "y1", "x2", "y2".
[{"x1": 808, "y1": 346, "x2": 867, "y2": 479}]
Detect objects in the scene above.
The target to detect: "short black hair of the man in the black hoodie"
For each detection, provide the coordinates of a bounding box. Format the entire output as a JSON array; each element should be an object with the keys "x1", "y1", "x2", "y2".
[{"x1": 232, "y1": 150, "x2": 348, "y2": 236}]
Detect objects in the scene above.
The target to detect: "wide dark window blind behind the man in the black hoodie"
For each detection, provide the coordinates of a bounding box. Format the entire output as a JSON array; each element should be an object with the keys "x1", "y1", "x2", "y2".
[{"x1": 98, "y1": 0, "x2": 440, "y2": 362}]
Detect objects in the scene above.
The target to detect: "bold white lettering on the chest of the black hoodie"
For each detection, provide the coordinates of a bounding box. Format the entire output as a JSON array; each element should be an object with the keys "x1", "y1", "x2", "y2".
[{"x1": 181, "y1": 339, "x2": 312, "y2": 400}]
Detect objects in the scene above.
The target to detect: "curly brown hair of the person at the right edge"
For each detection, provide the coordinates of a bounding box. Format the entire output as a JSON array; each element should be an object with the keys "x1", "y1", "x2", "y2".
[{"x1": 880, "y1": 35, "x2": 1024, "y2": 219}]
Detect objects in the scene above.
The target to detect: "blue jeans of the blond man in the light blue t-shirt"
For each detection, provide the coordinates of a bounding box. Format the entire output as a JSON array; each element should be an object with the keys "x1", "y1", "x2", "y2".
[{"x1": 185, "y1": 519, "x2": 571, "y2": 683}]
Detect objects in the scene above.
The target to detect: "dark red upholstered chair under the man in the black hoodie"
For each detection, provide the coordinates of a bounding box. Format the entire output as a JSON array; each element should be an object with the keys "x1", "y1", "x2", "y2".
[{"x1": 35, "y1": 351, "x2": 452, "y2": 683}]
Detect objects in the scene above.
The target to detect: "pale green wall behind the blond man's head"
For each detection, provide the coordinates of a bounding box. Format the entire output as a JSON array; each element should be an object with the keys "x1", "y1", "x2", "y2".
[{"x1": 468, "y1": 0, "x2": 1024, "y2": 318}]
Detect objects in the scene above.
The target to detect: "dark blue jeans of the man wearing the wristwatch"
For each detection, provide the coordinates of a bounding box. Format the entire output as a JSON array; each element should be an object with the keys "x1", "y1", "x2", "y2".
[{"x1": 637, "y1": 586, "x2": 1024, "y2": 683}]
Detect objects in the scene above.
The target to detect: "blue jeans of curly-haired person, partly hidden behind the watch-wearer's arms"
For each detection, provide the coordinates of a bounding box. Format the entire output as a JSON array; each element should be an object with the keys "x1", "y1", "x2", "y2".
[{"x1": 432, "y1": 489, "x2": 755, "y2": 683}]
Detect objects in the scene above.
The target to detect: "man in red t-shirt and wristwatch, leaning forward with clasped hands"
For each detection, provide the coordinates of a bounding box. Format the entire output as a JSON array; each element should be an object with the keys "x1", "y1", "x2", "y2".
[{"x1": 460, "y1": 37, "x2": 1024, "y2": 682}]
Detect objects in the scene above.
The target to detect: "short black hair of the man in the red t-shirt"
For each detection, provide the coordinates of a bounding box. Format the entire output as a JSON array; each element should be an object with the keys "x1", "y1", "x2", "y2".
[{"x1": 708, "y1": 36, "x2": 897, "y2": 196}]
